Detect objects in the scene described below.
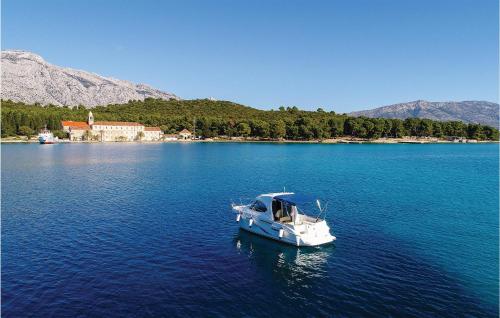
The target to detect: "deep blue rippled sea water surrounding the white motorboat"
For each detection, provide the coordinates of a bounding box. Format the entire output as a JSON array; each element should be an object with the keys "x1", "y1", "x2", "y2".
[{"x1": 1, "y1": 143, "x2": 499, "y2": 317}]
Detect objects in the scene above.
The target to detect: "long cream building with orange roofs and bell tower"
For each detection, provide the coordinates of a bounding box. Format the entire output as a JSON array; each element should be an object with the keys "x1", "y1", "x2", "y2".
[{"x1": 61, "y1": 112, "x2": 162, "y2": 141}]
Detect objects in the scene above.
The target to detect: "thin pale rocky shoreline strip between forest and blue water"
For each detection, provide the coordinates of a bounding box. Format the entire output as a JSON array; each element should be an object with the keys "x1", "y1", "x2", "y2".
[{"x1": 0, "y1": 138, "x2": 499, "y2": 144}]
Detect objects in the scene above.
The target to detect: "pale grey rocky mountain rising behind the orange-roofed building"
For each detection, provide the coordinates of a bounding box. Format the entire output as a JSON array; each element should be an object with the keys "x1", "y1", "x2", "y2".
[{"x1": 1, "y1": 51, "x2": 179, "y2": 107}]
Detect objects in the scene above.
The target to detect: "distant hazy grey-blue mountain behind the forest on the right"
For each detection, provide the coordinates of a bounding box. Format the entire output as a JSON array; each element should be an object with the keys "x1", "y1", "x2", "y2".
[{"x1": 349, "y1": 100, "x2": 499, "y2": 128}]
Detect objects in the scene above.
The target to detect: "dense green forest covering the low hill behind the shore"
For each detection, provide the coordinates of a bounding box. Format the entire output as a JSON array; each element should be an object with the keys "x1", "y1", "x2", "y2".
[{"x1": 1, "y1": 98, "x2": 499, "y2": 140}]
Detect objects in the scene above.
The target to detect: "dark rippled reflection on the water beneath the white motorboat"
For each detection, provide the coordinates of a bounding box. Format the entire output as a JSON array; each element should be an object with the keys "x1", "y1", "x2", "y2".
[{"x1": 234, "y1": 230, "x2": 335, "y2": 284}]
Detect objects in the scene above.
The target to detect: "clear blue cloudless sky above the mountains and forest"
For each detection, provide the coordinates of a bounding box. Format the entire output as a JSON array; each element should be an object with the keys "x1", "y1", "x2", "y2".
[{"x1": 2, "y1": 0, "x2": 499, "y2": 112}]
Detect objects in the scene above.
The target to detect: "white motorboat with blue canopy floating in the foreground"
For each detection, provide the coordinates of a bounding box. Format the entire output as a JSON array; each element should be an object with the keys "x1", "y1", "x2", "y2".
[{"x1": 232, "y1": 192, "x2": 336, "y2": 246}]
